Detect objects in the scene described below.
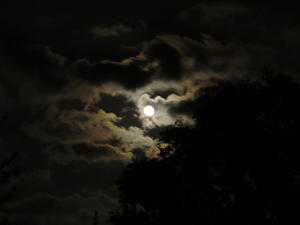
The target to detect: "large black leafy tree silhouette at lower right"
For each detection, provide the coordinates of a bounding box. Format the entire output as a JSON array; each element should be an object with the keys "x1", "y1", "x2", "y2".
[{"x1": 110, "y1": 72, "x2": 300, "y2": 225}]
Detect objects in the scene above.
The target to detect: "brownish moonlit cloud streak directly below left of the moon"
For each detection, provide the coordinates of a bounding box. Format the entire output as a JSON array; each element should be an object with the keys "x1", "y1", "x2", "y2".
[{"x1": 23, "y1": 109, "x2": 156, "y2": 157}]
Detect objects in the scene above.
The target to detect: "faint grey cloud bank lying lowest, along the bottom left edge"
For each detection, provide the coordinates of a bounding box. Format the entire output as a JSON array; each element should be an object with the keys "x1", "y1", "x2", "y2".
[{"x1": 9, "y1": 193, "x2": 116, "y2": 225}]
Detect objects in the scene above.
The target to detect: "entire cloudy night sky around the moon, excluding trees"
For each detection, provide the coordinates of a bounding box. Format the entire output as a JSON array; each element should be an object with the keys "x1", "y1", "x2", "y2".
[{"x1": 0, "y1": 0, "x2": 300, "y2": 225}]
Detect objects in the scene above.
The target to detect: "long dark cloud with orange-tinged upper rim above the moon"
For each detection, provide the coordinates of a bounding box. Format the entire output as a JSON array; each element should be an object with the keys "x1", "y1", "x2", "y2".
[{"x1": 73, "y1": 35, "x2": 253, "y2": 89}]
